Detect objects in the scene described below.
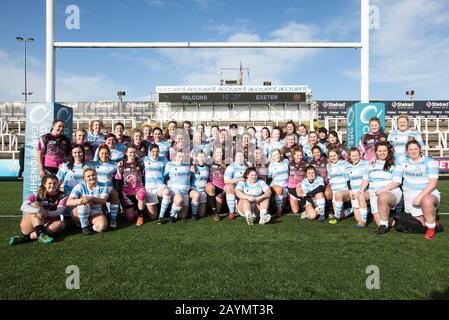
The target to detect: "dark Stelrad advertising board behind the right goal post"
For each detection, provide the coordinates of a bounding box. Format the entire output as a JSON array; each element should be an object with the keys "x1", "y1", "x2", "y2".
[{"x1": 317, "y1": 100, "x2": 449, "y2": 119}]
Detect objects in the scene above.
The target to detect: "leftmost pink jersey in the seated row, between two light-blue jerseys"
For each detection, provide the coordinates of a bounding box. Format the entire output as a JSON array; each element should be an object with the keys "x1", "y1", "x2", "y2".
[{"x1": 115, "y1": 161, "x2": 145, "y2": 196}]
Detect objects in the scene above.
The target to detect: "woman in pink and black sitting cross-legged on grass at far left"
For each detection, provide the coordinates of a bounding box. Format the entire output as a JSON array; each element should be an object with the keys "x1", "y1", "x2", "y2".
[{"x1": 8, "y1": 174, "x2": 67, "y2": 245}]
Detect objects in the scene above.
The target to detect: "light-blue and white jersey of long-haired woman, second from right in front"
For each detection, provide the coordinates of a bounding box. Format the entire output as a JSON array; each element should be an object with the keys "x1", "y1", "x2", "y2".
[{"x1": 363, "y1": 160, "x2": 402, "y2": 191}]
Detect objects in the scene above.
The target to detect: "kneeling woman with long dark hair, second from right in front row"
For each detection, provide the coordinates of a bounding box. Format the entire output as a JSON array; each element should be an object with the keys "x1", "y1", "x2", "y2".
[{"x1": 358, "y1": 141, "x2": 402, "y2": 234}]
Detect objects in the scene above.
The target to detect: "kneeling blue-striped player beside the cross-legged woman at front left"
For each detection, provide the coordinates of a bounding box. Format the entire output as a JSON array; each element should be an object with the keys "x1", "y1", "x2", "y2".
[{"x1": 67, "y1": 167, "x2": 108, "y2": 236}]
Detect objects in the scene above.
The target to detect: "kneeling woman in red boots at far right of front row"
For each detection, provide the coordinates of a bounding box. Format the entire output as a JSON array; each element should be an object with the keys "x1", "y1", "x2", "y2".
[{"x1": 398, "y1": 140, "x2": 441, "y2": 240}]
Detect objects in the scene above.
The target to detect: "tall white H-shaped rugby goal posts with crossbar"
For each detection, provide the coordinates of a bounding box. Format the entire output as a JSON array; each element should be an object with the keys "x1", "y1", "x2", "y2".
[{"x1": 45, "y1": 0, "x2": 370, "y2": 103}]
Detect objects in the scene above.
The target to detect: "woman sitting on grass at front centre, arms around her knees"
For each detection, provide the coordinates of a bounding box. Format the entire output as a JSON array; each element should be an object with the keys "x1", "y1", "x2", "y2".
[{"x1": 235, "y1": 168, "x2": 271, "y2": 225}]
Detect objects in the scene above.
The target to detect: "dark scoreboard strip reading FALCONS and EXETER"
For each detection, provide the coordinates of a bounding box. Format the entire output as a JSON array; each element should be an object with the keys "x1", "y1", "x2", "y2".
[{"x1": 159, "y1": 91, "x2": 306, "y2": 103}]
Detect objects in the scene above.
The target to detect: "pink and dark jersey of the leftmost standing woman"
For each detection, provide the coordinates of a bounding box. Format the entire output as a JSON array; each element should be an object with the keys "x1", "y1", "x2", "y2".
[{"x1": 37, "y1": 133, "x2": 71, "y2": 168}]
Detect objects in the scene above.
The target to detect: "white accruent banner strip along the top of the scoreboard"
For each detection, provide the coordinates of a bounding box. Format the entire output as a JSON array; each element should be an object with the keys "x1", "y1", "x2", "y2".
[{"x1": 156, "y1": 86, "x2": 311, "y2": 94}]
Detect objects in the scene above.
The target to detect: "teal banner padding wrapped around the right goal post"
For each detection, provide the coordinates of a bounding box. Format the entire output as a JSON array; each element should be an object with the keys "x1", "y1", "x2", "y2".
[{"x1": 346, "y1": 103, "x2": 385, "y2": 148}]
